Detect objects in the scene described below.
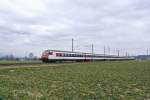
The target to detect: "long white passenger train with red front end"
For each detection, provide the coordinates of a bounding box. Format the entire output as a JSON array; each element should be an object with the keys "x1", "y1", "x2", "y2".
[{"x1": 41, "y1": 50, "x2": 134, "y2": 63}]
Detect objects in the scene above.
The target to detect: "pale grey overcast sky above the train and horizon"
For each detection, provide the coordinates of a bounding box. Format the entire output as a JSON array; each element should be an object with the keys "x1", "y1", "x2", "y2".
[{"x1": 0, "y1": 0, "x2": 150, "y2": 56}]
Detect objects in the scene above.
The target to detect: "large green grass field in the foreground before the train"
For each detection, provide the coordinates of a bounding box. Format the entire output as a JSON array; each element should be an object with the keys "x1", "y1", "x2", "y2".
[{"x1": 0, "y1": 61, "x2": 150, "y2": 100}]
